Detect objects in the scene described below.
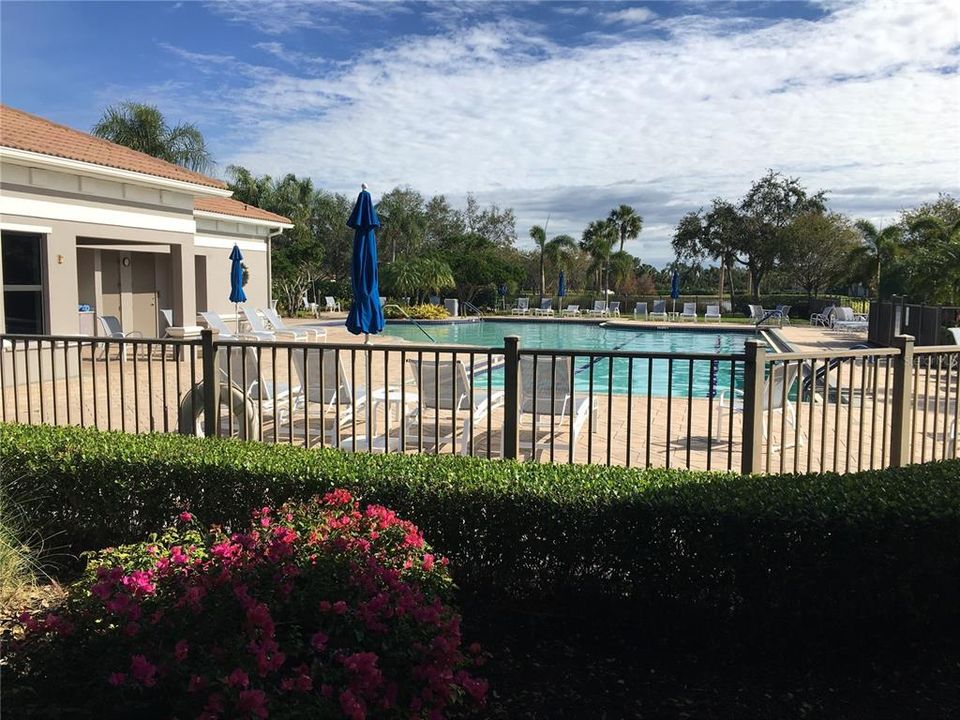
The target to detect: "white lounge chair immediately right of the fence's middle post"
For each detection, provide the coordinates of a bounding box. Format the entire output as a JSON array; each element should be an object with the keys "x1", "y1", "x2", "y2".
[{"x1": 516, "y1": 356, "x2": 598, "y2": 460}]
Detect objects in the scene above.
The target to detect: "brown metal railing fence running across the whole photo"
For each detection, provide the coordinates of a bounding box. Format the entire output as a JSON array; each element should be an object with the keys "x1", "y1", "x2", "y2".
[{"x1": 0, "y1": 332, "x2": 960, "y2": 473}]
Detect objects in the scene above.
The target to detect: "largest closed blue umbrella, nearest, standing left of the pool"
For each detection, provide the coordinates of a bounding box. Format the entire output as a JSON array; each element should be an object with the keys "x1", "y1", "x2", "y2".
[{"x1": 347, "y1": 183, "x2": 383, "y2": 340}]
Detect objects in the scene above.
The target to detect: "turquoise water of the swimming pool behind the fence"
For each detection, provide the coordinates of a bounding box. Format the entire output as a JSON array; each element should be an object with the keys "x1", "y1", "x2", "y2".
[{"x1": 384, "y1": 320, "x2": 762, "y2": 398}]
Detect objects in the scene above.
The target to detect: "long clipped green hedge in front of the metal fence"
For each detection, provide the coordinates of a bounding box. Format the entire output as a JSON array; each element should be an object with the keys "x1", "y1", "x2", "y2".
[{"x1": 0, "y1": 425, "x2": 960, "y2": 625}]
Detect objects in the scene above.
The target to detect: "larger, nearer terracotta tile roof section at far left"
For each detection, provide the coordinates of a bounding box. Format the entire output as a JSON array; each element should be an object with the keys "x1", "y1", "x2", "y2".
[{"x1": 0, "y1": 105, "x2": 226, "y2": 188}]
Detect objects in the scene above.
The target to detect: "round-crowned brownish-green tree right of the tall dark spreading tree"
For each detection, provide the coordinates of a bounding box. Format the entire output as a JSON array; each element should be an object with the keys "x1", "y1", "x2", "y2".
[{"x1": 782, "y1": 212, "x2": 859, "y2": 300}]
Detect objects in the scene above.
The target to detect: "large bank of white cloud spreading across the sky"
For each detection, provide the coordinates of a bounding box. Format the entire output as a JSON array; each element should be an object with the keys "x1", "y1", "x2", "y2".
[{"x1": 158, "y1": 0, "x2": 960, "y2": 263}]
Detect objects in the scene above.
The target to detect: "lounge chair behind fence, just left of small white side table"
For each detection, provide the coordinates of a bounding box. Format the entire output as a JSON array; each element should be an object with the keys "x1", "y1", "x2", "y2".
[{"x1": 291, "y1": 348, "x2": 367, "y2": 450}]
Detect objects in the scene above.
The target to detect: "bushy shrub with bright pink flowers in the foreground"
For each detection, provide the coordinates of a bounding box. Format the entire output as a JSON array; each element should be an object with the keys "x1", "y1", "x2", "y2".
[{"x1": 5, "y1": 490, "x2": 486, "y2": 720}]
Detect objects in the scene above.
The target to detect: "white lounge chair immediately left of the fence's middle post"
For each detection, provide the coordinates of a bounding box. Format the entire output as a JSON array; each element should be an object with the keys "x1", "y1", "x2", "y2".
[{"x1": 405, "y1": 359, "x2": 503, "y2": 455}]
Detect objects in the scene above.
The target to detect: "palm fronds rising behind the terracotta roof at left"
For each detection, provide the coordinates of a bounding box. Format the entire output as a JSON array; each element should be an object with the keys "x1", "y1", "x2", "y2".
[{"x1": 92, "y1": 102, "x2": 214, "y2": 172}]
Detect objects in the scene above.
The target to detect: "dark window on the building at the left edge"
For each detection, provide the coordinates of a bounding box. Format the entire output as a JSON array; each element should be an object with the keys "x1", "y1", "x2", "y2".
[{"x1": 0, "y1": 232, "x2": 44, "y2": 335}]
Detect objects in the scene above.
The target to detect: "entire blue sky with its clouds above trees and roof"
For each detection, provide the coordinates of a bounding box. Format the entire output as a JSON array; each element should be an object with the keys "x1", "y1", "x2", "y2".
[{"x1": 0, "y1": 0, "x2": 960, "y2": 265}]
